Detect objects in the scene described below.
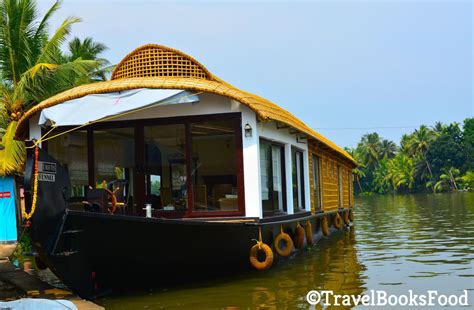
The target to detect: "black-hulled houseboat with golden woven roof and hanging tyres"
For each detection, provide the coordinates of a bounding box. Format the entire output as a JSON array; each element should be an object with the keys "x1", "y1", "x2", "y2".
[{"x1": 16, "y1": 44, "x2": 356, "y2": 297}]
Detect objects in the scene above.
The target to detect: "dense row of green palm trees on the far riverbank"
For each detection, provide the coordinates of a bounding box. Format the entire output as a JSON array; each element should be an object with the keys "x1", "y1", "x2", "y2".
[{"x1": 348, "y1": 118, "x2": 474, "y2": 193}]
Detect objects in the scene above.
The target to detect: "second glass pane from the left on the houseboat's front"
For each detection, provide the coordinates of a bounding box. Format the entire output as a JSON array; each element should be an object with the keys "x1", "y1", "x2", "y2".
[{"x1": 94, "y1": 128, "x2": 136, "y2": 203}]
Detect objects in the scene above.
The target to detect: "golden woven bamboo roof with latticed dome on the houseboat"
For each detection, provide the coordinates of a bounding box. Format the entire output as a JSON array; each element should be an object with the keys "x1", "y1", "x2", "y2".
[{"x1": 16, "y1": 44, "x2": 355, "y2": 164}]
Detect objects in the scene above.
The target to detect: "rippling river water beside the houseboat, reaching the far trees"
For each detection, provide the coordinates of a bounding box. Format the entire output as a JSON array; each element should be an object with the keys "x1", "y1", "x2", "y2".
[{"x1": 99, "y1": 193, "x2": 474, "y2": 309}]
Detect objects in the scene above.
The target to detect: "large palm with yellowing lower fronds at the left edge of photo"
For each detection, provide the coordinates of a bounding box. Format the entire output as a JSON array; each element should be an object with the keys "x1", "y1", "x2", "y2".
[{"x1": 0, "y1": 0, "x2": 103, "y2": 175}]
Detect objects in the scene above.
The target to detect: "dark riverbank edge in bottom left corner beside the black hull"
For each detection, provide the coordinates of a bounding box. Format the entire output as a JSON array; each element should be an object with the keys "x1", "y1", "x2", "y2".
[{"x1": 0, "y1": 260, "x2": 104, "y2": 310}]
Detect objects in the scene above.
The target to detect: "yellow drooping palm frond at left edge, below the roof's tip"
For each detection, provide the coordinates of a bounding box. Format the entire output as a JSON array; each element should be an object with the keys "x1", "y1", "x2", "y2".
[{"x1": 0, "y1": 122, "x2": 26, "y2": 176}]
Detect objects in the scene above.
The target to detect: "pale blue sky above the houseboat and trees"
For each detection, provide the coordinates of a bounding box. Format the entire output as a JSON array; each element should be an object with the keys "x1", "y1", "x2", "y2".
[{"x1": 38, "y1": 0, "x2": 474, "y2": 147}]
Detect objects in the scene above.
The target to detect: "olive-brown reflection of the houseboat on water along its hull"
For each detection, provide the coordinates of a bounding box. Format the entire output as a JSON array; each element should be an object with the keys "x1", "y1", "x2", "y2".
[{"x1": 100, "y1": 224, "x2": 364, "y2": 309}]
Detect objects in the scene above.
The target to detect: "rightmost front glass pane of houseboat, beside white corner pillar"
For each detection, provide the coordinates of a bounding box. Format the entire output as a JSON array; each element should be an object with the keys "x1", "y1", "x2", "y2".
[{"x1": 190, "y1": 120, "x2": 240, "y2": 211}]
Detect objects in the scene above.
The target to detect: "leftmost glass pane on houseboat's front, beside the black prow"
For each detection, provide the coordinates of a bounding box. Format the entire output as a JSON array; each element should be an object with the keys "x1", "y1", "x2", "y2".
[{"x1": 47, "y1": 130, "x2": 89, "y2": 197}]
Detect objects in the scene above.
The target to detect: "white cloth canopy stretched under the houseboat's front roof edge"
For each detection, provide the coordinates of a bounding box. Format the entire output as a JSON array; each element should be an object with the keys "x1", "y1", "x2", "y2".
[{"x1": 38, "y1": 88, "x2": 199, "y2": 126}]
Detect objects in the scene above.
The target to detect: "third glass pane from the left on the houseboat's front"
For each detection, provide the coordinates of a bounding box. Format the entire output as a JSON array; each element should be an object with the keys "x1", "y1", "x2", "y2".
[{"x1": 144, "y1": 124, "x2": 187, "y2": 211}]
